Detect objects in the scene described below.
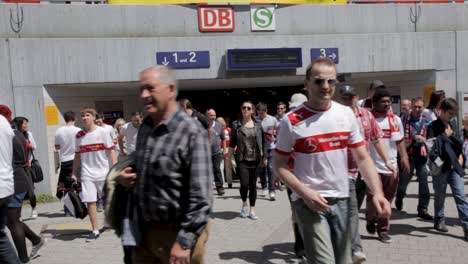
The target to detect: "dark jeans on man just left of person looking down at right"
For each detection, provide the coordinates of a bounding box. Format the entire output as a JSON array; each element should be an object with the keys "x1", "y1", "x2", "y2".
[{"x1": 396, "y1": 157, "x2": 431, "y2": 212}]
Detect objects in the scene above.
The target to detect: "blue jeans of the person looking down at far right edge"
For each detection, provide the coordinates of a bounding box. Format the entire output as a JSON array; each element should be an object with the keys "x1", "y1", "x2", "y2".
[{"x1": 432, "y1": 170, "x2": 468, "y2": 228}]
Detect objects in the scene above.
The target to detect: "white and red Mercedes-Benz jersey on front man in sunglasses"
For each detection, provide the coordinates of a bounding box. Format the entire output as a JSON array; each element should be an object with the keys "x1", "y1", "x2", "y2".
[{"x1": 276, "y1": 101, "x2": 365, "y2": 198}]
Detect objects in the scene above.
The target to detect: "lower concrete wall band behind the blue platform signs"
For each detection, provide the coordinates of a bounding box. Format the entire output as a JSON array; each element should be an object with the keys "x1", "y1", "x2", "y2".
[{"x1": 6, "y1": 32, "x2": 455, "y2": 86}]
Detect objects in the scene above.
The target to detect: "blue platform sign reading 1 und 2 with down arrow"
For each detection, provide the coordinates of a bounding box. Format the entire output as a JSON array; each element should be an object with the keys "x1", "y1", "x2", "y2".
[{"x1": 156, "y1": 50, "x2": 210, "y2": 69}]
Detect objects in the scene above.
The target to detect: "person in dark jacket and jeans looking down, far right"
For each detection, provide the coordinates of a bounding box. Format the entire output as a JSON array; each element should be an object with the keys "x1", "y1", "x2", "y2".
[{"x1": 427, "y1": 98, "x2": 468, "y2": 241}]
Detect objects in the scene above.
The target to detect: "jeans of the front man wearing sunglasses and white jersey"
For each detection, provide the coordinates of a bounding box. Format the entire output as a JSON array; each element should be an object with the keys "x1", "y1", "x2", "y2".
[{"x1": 293, "y1": 198, "x2": 351, "y2": 264}]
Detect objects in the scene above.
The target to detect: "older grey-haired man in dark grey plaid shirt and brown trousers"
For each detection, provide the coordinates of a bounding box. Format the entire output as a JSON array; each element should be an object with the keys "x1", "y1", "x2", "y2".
[{"x1": 119, "y1": 66, "x2": 213, "y2": 264}]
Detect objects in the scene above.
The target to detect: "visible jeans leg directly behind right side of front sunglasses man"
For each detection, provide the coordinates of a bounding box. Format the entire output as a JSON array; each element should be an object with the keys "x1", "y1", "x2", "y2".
[{"x1": 349, "y1": 178, "x2": 362, "y2": 253}]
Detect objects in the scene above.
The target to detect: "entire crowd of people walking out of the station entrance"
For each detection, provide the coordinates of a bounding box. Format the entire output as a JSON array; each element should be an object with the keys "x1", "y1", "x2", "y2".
[{"x1": 0, "y1": 61, "x2": 468, "y2": 264}]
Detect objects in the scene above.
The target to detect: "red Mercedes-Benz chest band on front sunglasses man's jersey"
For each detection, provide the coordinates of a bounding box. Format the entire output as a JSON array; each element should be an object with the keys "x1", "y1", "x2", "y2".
[{"x1": 294, "y1": 132, "x2": 350, "y2": 154}]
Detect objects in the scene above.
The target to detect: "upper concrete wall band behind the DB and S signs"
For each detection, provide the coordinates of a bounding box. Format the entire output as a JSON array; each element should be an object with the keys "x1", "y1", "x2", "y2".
[{"x1": 0, "y1": 4, "x2": 468, "y2": 38}]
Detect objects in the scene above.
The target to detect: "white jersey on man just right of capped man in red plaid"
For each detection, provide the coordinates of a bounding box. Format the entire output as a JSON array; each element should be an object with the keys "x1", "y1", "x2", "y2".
[{"x1": 370, "y1": 115, "x2": 405, "y2": 174}]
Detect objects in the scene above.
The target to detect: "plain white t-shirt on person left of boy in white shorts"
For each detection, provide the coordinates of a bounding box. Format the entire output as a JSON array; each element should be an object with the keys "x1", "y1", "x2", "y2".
[{"x1": 55, "y1": 126, "x2": 81, "y2": 162}]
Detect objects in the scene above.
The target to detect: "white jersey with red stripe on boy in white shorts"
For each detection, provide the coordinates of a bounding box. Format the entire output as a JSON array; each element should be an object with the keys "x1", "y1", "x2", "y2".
[{"x1": 76, "y1": 126, "x2": 114, "y2": 181}]
